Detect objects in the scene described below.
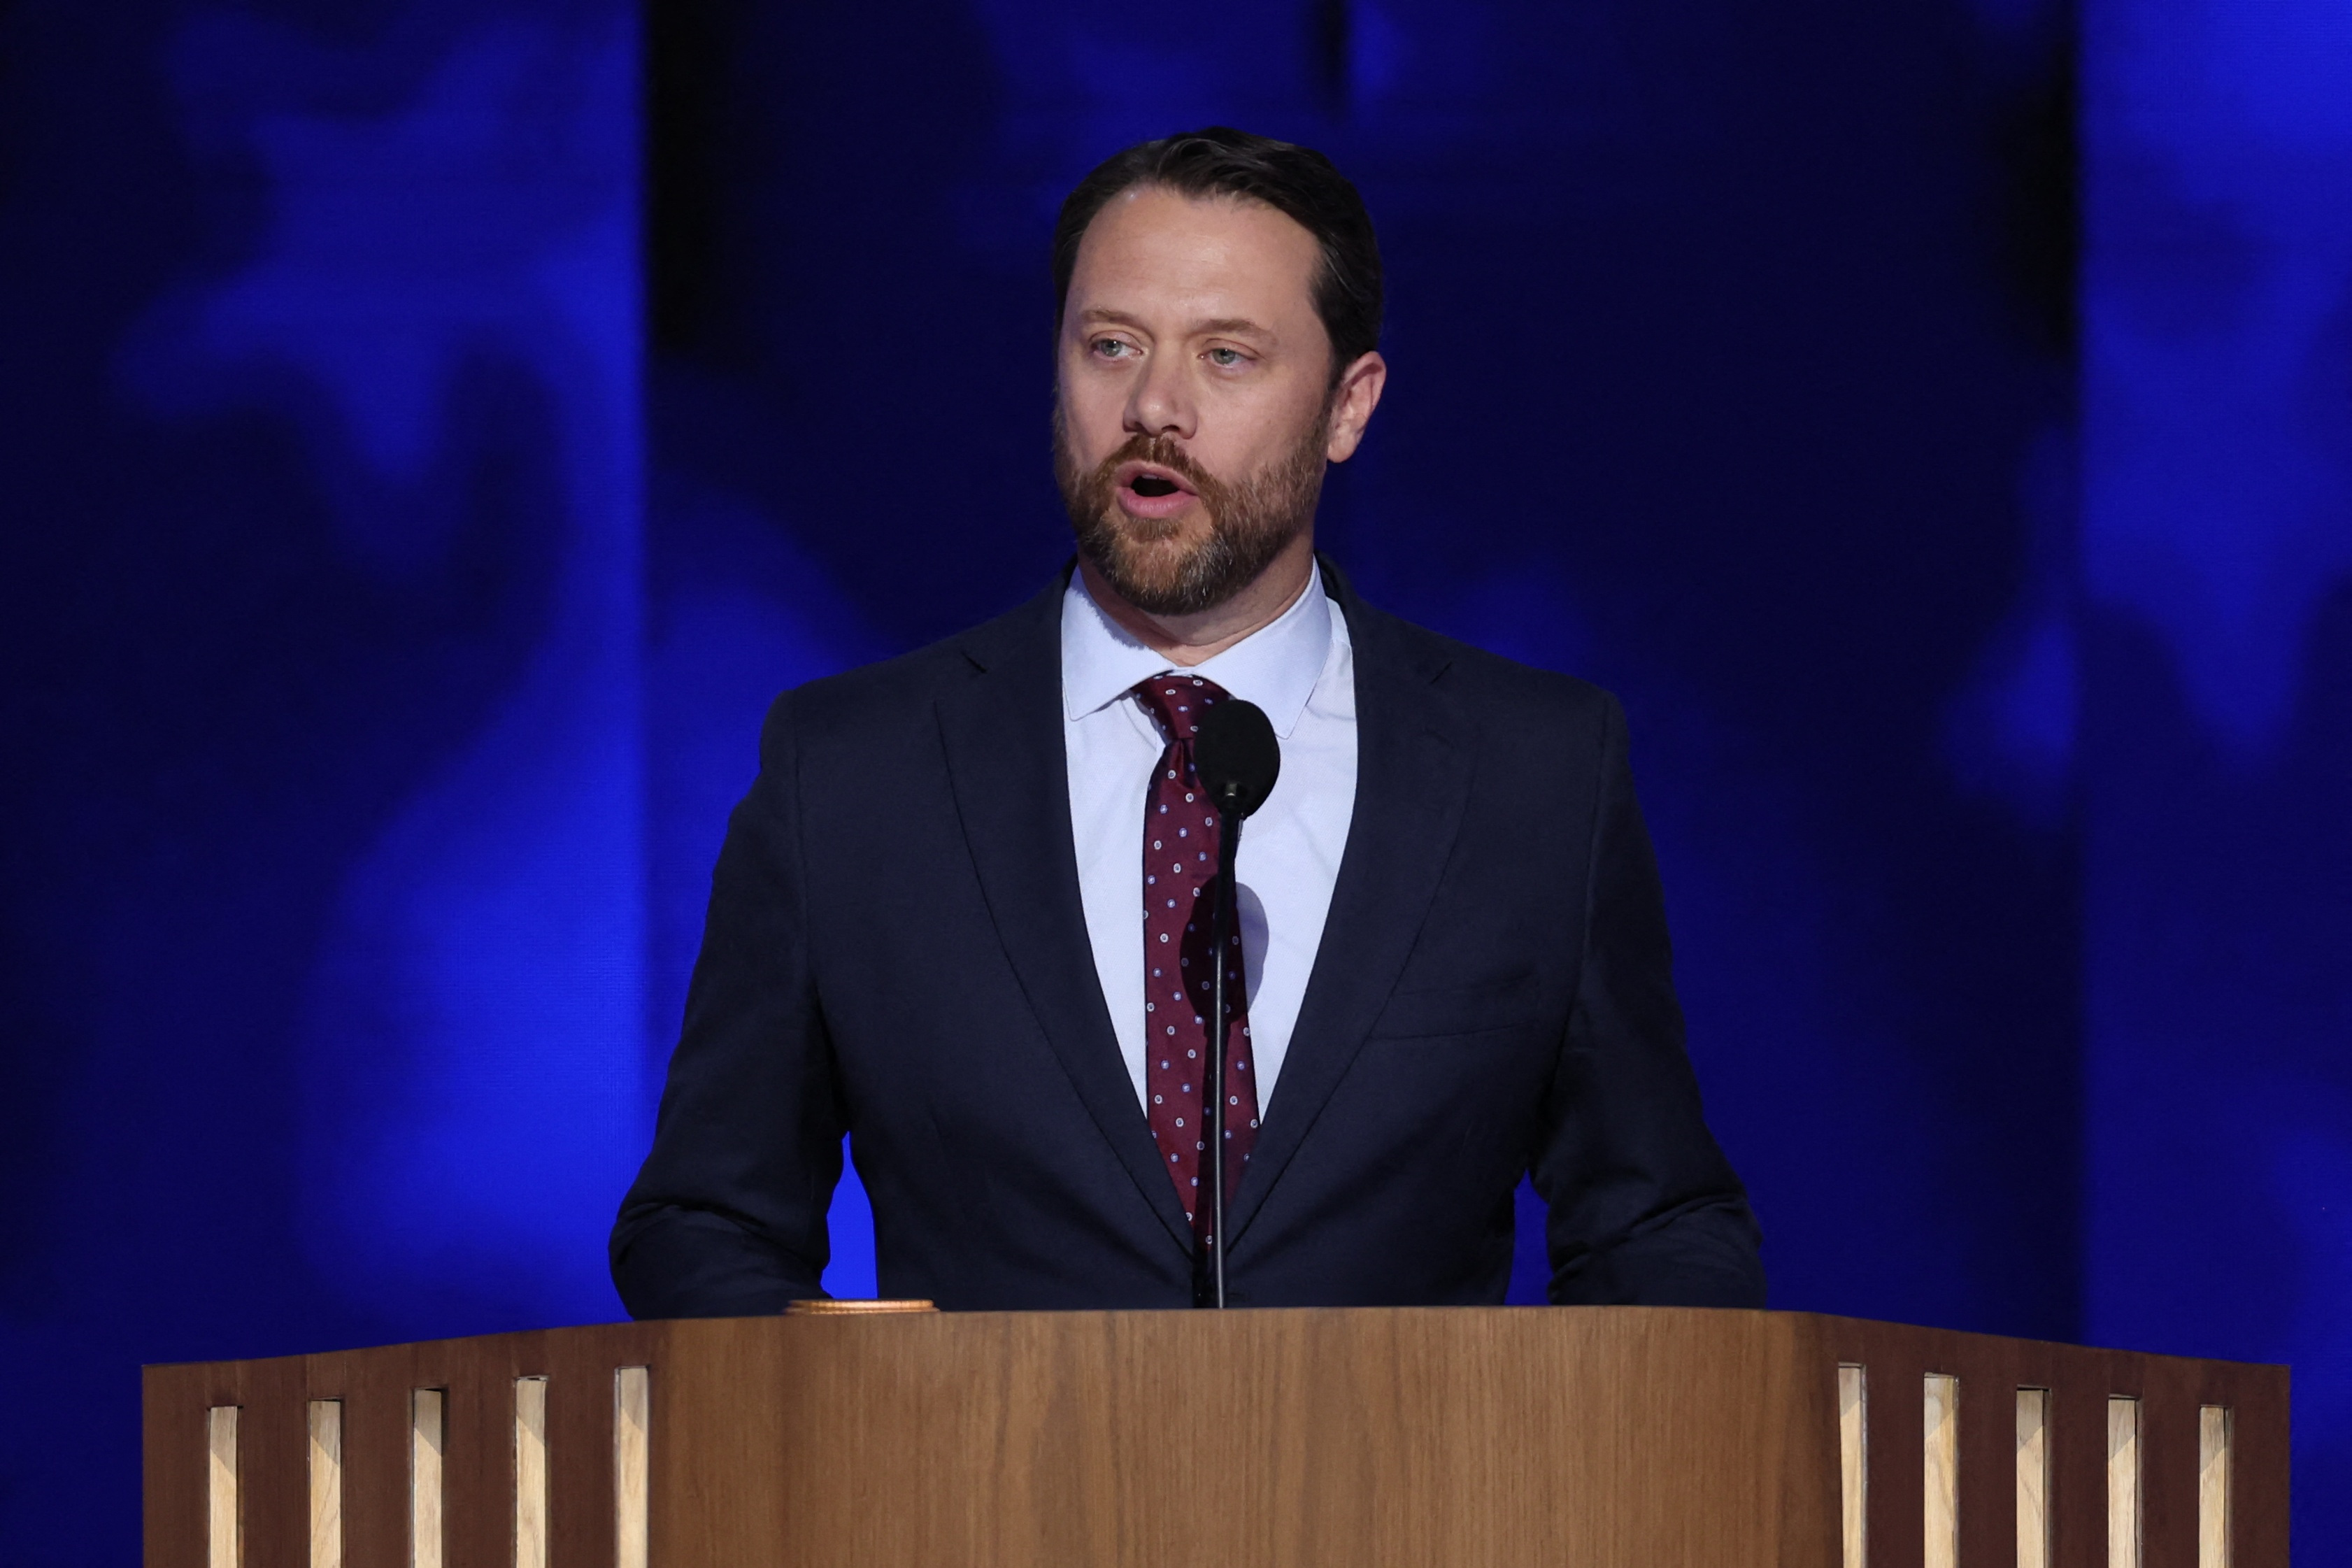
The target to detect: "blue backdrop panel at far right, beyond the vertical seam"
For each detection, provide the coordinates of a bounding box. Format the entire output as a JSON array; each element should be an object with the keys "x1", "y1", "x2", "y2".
[{"x1": 2072, "y1": 0, "x2": 2352, "y2": 1532}]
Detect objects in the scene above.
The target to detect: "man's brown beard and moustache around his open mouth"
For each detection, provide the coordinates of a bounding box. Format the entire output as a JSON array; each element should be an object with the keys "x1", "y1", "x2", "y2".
[{"x1": 1054, "y1": 404, "x2": 1331, "y2": 616}]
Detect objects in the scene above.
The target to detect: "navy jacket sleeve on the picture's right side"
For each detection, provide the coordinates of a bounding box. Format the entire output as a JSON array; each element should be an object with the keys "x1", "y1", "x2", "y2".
[{"x1": 1534, "y1": 698, "x2": 1764, "y2": 1307}]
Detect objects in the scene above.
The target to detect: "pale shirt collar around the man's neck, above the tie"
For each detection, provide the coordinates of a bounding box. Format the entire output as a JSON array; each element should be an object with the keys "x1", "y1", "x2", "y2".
[{"x1": 1061, "y1": 569, "x2": 1334, "y2": 738}]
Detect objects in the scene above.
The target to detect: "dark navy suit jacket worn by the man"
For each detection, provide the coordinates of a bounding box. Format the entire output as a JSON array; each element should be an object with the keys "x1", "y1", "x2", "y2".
[{"x1": 611, "y1": 562, "x2": 1764, "y2": 1316}]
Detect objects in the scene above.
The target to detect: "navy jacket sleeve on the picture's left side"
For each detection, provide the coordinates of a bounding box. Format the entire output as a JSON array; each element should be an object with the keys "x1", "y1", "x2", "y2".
[{"x1": 611, "y1": 694, "x2": 844, "y2": 1316}]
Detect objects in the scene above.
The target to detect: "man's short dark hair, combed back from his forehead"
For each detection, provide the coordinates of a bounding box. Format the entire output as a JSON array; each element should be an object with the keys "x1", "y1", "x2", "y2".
[{"x1": 1054, "y1": 124, "x2": 1381, "y2": 385}]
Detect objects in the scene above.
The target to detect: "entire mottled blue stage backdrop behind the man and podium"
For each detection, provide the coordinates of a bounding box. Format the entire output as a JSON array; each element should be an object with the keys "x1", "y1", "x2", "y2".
[{"x1": 0, "y1": 0, "x2": 2352, "y2": 1568}]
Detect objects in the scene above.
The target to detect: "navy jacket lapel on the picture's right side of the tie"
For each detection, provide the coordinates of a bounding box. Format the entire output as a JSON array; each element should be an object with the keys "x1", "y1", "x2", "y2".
[{"x1": 1223, "y1": 562, "x2": 1472, "y2": 1243}]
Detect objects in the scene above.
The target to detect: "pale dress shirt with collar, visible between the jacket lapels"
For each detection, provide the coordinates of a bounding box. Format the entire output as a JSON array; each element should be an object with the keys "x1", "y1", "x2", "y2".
[{"x1": 1061, "y1": 571, "x2": 1355, "y2": 1117}]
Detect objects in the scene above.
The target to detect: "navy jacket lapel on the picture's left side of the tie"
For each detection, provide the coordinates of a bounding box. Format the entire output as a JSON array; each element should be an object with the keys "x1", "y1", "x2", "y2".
[{"x1": 939, "y1": 576, "x2": 1192, "y2": 1253}]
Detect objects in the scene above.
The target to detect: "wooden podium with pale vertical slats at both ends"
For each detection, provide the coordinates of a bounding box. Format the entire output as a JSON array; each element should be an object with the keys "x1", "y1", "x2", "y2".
[{"x1": 146, "y1": 1307, "x2": 2286, "y2": 1568}]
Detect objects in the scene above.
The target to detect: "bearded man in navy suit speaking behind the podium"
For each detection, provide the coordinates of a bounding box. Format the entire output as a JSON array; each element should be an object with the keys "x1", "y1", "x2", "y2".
[{"x1": 611, "y1": 127, "x2": 1764, "y2": 1316}]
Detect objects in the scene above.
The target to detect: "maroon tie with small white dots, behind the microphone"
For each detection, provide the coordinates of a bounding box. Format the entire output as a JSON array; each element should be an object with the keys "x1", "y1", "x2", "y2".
[{"x1": 1136, "y1": 675, "x2": 1258, "y2": 1243}]
